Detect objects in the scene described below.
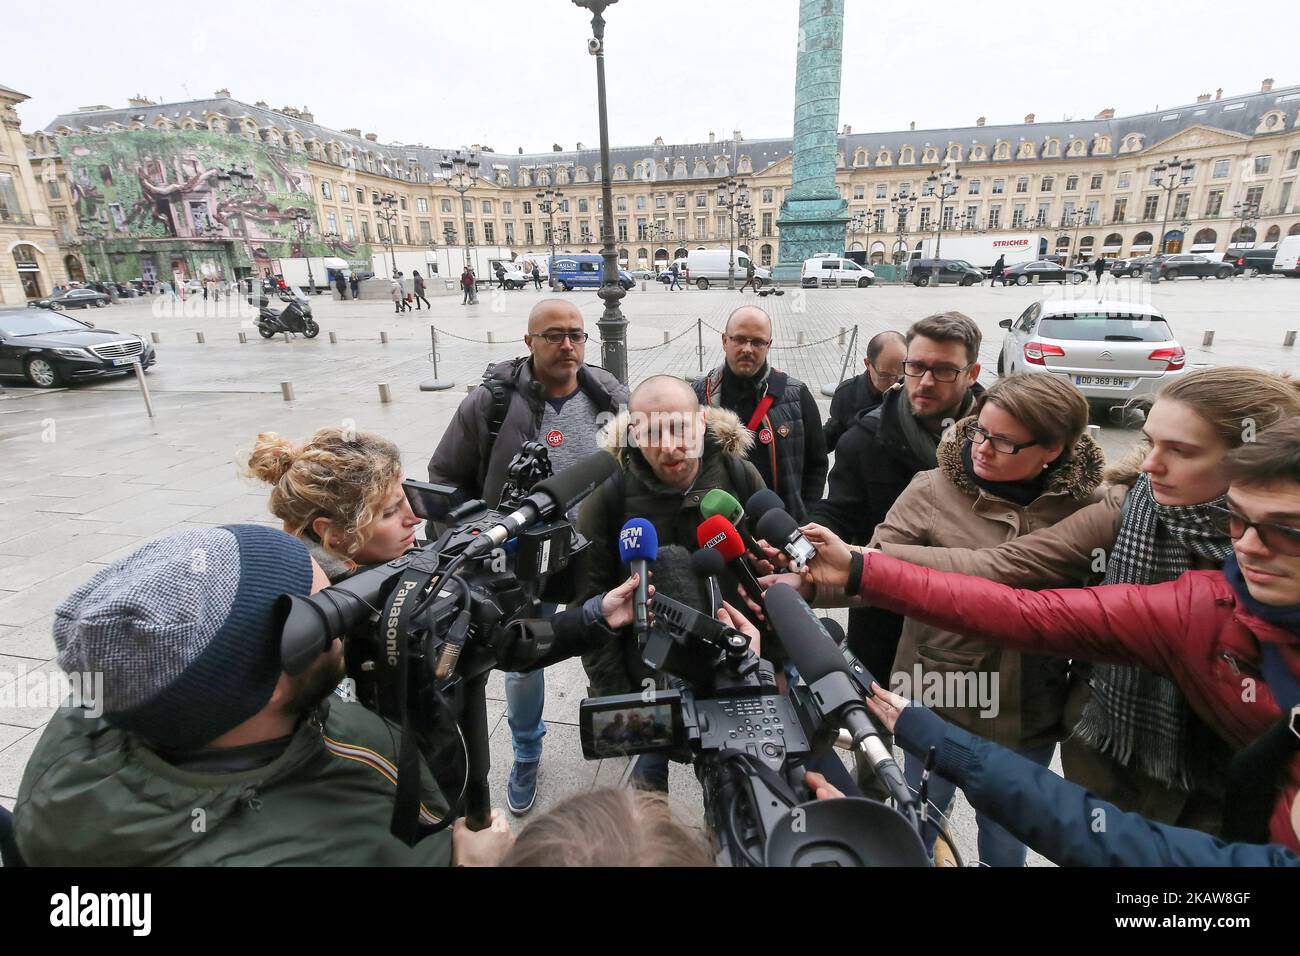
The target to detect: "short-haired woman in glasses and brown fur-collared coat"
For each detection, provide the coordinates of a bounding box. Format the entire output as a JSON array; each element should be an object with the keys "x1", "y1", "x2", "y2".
[{"x1": 852, "y1": 375, "x2": 1104, "y2": 866}]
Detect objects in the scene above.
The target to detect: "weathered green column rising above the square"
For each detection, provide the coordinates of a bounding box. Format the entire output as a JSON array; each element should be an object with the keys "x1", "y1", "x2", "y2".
[{"x1": 774, "y1": 0, "x2": 849, "y2": 281}]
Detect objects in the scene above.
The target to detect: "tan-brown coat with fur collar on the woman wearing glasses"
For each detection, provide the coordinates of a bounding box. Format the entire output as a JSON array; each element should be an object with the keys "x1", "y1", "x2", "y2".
[{"x1": 871, "y1": 419, "x2": 1114, "y2": 750}]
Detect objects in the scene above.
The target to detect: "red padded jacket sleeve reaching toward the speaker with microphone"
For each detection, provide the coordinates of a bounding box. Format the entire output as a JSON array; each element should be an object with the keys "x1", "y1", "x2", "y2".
[{"x1": 862, "y1": 551, "x2": 1188, "y2": 675}]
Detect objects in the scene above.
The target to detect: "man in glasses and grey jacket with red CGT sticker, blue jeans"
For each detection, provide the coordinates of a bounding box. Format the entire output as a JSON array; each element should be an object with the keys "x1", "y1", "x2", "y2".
[{"x1": 429, "y1": 299, "x2": 628, "y2": 814}]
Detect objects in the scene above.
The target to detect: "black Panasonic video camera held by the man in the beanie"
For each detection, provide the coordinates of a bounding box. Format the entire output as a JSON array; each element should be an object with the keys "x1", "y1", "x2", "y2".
[{"x1": 276, "y1": 442, "x2": 616, "y2": 844}]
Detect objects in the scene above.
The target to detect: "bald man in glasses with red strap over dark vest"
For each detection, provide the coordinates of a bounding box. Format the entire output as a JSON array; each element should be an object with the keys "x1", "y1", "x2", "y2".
[{"x1": 694, "y1": 306, "x2": 829, "y2": 522}]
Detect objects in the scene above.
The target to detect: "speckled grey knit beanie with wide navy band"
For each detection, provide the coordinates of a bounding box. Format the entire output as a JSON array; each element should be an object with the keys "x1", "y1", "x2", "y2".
[{"x1": 55, "y1": 524, "x2": 312, "y2": 750}]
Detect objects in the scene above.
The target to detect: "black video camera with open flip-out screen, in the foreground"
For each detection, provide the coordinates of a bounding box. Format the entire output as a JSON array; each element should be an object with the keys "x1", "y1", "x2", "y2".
[{"x1": 579, "y1": 548, "x2": 930, "y2": 866}]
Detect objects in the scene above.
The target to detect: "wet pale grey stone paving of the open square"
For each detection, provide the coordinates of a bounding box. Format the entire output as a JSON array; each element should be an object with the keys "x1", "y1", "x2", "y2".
[{"x1": 0, "y1": 277, "x2": 1300, "y2": 862}]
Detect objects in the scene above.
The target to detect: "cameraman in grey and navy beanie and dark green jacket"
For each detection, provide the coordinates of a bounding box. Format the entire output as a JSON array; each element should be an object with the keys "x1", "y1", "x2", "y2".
[{"x1": 14, "y1": 525, "x2": 512, "y2": 866}]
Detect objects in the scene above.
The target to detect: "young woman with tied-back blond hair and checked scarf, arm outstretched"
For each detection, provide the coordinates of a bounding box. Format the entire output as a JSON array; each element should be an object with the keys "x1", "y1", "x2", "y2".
[{"x1": 790, "y1": 365, "x2": 1300, "y2": 834}]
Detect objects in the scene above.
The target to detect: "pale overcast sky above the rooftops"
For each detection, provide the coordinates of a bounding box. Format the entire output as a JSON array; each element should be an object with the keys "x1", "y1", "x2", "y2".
[{"x1": 0, "y1": 0, "x2": 1300, "y2": 152}]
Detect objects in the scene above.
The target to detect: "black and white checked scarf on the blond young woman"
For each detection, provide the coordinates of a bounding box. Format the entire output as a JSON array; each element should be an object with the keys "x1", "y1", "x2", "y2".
[{"x1": 1074, "y1": 475, "x2": 1232, "y2": 790}]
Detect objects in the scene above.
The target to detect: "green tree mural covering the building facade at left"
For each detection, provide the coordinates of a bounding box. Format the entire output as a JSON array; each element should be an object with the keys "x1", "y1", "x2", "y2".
[{"x1": 59, "y1": 130, "x2": 369, "y2": 274}]
